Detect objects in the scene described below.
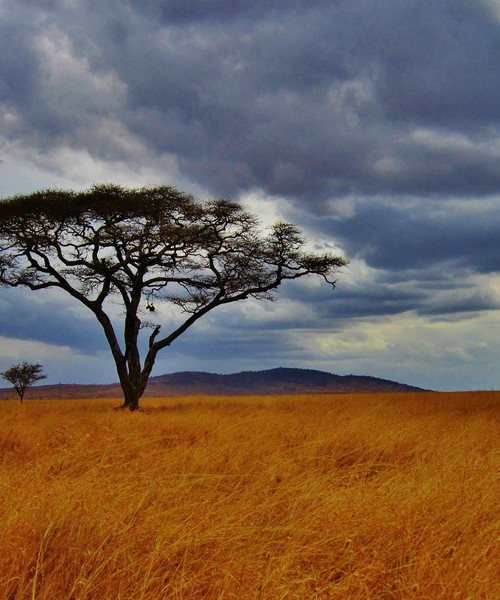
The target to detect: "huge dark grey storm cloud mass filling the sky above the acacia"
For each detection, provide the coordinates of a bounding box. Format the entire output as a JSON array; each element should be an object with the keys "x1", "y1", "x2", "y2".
[{"x1": 3, "y1": 0, "x2": 500, "y2": 199}]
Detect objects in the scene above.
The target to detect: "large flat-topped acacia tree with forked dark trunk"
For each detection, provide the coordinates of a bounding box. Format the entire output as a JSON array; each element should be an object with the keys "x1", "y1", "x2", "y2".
[{"x1": 0, "y1": 185, "x2": 347, "y2": 410}]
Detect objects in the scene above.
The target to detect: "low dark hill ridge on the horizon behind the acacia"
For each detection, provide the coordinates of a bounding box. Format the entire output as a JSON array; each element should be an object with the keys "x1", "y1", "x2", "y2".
[{"x1": 0, "y1": 367, "x2": 427, "y2": 399}]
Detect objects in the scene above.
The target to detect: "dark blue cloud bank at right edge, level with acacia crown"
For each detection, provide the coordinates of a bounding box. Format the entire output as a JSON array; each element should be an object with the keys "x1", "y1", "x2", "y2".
[{"x1": 321, "y1": 199, "x2": 500, "y2": 273}]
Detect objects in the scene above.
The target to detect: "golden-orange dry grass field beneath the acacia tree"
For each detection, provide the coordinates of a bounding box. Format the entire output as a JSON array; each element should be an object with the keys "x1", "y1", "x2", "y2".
[{"x1": 0, "y1": 392, "x2": 500, "y2": 600}]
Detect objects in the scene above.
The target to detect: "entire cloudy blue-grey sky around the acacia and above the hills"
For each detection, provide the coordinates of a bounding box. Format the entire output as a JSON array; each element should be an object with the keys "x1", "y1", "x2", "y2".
[{"x1": 0, "y1": 0, "x2": 500, "y2": 390}]
